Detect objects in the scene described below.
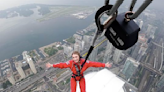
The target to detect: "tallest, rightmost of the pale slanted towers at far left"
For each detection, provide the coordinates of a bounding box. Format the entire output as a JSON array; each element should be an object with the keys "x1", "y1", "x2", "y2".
[{"x1": 22, "y1": 51, "x2": 37, "y2": 74}]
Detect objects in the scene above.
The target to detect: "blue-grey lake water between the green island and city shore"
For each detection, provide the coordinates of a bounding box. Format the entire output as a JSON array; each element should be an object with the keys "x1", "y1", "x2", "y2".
[{"x1": 0, "y1": 11, "x2": 94, "y2": 60}]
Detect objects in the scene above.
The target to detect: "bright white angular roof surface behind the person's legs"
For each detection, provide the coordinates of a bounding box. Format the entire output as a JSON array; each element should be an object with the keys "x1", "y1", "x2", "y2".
[{"x1": 76, "y1": 69, "x2": 126, "y2": 92}]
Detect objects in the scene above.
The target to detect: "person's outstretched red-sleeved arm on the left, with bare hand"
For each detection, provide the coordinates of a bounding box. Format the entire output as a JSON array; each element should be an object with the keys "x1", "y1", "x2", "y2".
[{"x1": 46, "y1": 61, "x2": 70, "y2": 68}]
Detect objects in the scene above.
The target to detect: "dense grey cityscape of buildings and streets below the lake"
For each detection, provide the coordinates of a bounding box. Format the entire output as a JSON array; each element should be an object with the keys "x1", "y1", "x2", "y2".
[{"x1": 0, "y1": 1, "x2": 164, "y2": 92}]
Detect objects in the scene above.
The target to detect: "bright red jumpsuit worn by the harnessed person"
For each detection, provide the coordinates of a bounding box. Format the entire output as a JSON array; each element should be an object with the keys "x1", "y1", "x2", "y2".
[{"x1": 53, "y1": 59, "x2": 105, "y2": 92}]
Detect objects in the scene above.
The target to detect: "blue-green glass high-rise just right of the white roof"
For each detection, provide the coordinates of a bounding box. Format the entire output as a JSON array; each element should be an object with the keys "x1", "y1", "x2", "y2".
[{"x1": 122, "y1": 57, "x2": 139, "y2": 80}]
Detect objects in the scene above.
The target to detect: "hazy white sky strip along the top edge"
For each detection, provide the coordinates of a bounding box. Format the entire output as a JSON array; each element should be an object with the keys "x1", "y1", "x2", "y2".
[{"x1": 0, "y1": 0, "x2": 164, "y2": 10}]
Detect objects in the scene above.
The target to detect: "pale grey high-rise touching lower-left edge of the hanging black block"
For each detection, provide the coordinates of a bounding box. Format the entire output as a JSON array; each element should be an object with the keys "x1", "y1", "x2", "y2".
[{"x1": 103, "y1": 41, "x2": 113, "y2": 63}]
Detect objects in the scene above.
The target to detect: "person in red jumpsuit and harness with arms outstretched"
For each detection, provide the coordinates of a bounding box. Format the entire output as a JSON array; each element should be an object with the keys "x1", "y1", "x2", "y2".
[{"x1": 46, "y1": 51, "x2": 111, "y2": 92}]
